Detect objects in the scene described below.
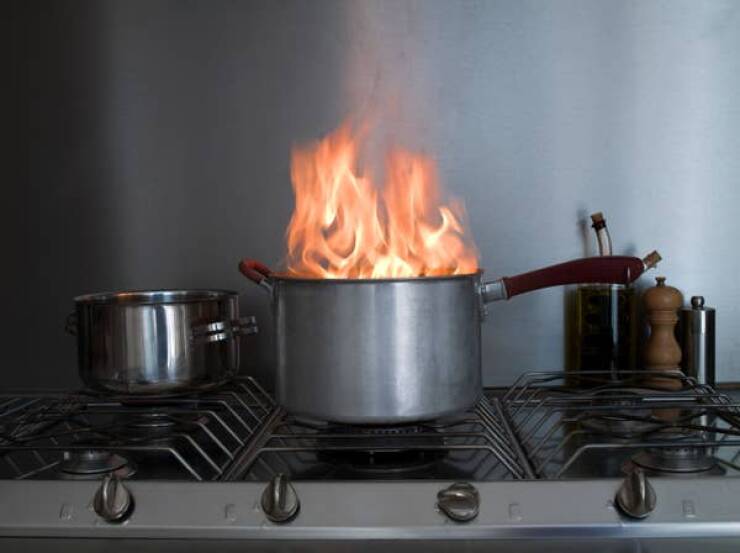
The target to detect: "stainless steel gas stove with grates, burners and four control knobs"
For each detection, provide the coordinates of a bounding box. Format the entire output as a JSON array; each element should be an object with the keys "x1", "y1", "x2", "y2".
[{"x1": 0, "y1": 371, "x2": 740, "y2": 551}]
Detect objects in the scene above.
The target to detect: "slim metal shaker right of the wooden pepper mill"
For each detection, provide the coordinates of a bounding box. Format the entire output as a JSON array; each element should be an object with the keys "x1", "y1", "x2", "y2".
[{"x1": 678, "y1": 296, "x2": 716, "y2": 386}]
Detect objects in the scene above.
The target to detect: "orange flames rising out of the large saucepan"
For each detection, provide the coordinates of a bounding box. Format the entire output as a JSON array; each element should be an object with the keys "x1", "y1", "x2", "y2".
[{"x1": 287, "y1": 124, "x2": 478, "y2": 278}]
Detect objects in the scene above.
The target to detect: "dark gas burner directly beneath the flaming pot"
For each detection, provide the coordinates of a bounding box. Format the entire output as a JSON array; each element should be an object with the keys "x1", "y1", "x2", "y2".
[{"x1": 319, "y1": 425, "x2": 447, "y2": 476}]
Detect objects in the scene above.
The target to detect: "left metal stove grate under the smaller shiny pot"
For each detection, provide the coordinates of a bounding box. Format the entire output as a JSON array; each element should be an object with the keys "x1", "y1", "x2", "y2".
[{"x1": 0, "y1": 378, "x2": 275, "y2": 480}]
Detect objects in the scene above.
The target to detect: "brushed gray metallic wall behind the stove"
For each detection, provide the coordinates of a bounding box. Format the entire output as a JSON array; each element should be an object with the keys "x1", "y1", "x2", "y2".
[{"x1": 8, "y1": 0, "x2": 740, "y2": 386}]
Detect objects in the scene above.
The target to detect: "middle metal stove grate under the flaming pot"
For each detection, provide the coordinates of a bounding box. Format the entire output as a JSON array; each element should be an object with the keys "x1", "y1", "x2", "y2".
[{"x1": 223, "y1": 398, "x2": 531, "y2": 481}]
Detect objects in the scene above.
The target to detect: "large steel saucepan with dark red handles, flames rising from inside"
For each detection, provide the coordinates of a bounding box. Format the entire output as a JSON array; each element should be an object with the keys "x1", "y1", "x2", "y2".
[{"x1": 239, "y1": 254, "x2": 659, "y2": 424}]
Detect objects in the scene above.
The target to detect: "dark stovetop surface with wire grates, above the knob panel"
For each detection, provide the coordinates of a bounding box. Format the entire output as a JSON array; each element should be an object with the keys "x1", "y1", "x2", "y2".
[{"x1": 0, "y1": 371, "x2": 740, "y2": 481}]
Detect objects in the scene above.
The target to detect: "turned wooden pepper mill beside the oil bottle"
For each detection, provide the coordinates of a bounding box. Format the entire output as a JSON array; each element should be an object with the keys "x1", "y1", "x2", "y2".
[{"x1": 643, "y1": 277, "x2": 683, "y2": 390}]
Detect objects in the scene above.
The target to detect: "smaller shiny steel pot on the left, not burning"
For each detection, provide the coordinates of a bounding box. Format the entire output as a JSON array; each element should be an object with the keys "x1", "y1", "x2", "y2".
[{"x1": 67, "y1": 290, "x2": 257, "y2": 394}]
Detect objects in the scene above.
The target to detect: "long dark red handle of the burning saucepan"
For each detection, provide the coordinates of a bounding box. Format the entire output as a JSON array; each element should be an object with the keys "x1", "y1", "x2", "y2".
[{"x1": 481, "y1": 251, "x2": 661, "y2": 303}]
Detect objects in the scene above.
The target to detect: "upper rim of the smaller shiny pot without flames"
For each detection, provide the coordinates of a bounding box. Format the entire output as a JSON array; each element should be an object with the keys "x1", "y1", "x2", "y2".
[{"x1": 74, "y1": 288, "x2": 239, "y2": 305}]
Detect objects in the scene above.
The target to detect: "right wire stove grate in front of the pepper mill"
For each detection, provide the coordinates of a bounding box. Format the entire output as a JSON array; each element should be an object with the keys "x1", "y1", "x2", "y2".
[{"x1": 494, "y1": 371, "x2": 740, "y2": 479}]
